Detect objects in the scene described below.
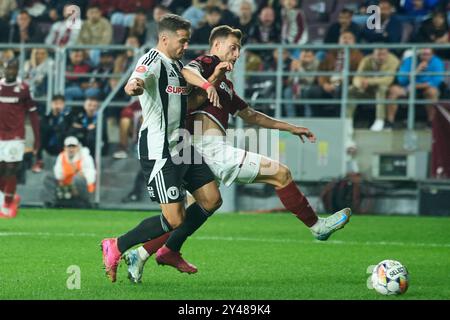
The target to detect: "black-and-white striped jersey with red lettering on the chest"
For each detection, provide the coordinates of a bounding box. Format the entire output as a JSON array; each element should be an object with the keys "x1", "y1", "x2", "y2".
[{"x1": 130, "y1": 49, "x2": 189, "y2": 160}]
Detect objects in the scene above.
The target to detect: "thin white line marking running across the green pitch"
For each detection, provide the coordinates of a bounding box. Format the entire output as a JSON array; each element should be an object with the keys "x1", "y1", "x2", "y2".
[{"x1": 0, "y1": 232, "x2": 450, "y2": 248}]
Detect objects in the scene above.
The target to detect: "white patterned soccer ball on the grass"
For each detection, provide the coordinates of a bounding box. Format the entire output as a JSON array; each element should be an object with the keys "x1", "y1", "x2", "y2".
[{"x1": 371, "y1": 260, "x2": 409, "y2": 296}]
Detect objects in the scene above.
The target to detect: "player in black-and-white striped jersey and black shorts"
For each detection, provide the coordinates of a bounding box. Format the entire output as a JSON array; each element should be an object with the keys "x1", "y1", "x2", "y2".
[{"x1": 101, "y1": 15, "x2": 222, "y2": 282}]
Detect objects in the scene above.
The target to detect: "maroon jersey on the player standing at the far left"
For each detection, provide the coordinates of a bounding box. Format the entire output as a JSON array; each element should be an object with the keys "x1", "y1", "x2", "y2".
[{"x1": 0, "y1": 79, "x2": 37, "y2": 140}]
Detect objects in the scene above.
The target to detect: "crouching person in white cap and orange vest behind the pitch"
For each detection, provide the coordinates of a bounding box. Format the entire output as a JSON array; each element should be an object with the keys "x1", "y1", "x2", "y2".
[{"x1": 42, "y1": 136, "x2": 96, "y2": 207}]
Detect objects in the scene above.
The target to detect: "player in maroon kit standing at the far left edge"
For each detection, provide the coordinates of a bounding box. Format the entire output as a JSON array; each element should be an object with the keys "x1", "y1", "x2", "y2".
[{"x1": 0, "y1": 60, "x2": 40, "y2": 218}]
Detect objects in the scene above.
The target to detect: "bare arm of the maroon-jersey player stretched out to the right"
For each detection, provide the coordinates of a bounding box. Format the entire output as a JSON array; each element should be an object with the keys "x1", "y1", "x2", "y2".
[{"x1": 238, "y1": 107, "x2": 316, "y2": 142}]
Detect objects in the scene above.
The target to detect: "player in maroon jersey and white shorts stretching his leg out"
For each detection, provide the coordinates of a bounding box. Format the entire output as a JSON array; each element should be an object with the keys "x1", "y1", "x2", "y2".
[{"x1": 124, "y1": 26, "x2": 351, "y2": 282}]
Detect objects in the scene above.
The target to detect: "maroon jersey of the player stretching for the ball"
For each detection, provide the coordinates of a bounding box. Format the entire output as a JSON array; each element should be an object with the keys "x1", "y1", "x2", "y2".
[{"x1": 188, "y1": 55, "x2": 248, "y2": 132}]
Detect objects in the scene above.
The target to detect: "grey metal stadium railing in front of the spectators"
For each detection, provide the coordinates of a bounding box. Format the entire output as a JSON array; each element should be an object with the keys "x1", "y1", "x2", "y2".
[{"x1": 0, "y1": 43, "x2": 450, "y2": 203}]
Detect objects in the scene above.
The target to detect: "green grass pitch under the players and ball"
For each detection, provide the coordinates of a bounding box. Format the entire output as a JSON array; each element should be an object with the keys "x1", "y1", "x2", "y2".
[{"x1": 0, "y1": 209, "x2": 450, "y2": 300}]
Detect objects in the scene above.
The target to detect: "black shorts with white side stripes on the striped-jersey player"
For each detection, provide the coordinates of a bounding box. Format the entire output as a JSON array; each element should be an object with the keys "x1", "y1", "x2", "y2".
[{"x1": 140, "y1": 148, "x2": 215, "y2": 204}]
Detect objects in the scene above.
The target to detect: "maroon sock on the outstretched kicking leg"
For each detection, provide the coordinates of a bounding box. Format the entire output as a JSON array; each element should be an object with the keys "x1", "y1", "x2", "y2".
[{"x1": 275, "y1": 181, "x2": 318, "y2": 227}]
